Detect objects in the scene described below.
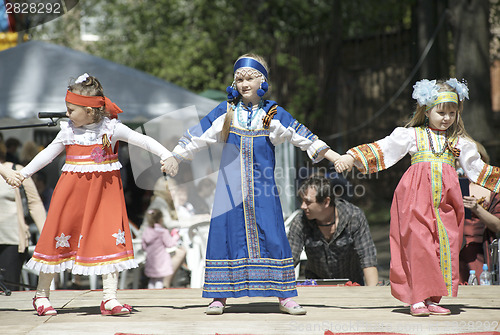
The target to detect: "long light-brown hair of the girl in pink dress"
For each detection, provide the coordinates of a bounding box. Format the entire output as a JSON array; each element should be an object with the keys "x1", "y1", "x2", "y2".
[{"x1": 405, "y1": 80, "x2": 472, "y2": 140}]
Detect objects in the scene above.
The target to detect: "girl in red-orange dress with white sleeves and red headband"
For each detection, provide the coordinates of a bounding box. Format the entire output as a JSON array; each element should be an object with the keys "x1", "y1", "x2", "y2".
[{"x1": 9, "y1": 73, "x2": 177, "y2": 316}]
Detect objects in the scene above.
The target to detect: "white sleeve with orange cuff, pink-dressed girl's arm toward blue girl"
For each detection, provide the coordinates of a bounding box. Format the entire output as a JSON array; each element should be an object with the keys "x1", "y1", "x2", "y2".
[{"x1": 347, "y1": 127, "x2": 416, "y2": 173}]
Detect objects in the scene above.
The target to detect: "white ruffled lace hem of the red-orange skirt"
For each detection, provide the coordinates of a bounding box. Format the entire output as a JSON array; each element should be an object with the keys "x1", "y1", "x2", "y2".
[{"x1": 26, "y1": 258, "x2": 138, "y2": 276}]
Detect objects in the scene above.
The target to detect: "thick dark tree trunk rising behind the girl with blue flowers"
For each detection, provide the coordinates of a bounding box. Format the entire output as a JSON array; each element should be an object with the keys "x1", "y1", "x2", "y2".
[{"x1": 450, "y1": 0, "x2": 493, "y2": 142}]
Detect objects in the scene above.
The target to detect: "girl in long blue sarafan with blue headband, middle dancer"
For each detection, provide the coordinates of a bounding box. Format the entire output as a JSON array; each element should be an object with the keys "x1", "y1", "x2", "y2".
[{"x1": 173, "y1": 54, "x2": 340, "y2": 315}]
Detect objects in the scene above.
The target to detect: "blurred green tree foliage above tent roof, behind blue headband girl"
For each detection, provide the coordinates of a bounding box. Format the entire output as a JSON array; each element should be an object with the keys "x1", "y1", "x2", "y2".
[{"x1": 82, "y1": 0, "x2": 413, "y2": 121}]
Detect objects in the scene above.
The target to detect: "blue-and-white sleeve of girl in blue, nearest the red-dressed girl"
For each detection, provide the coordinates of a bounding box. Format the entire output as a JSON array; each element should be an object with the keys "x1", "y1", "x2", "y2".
[{"x1": 172, "y1": 101, "x2": 227, "y2": 161}]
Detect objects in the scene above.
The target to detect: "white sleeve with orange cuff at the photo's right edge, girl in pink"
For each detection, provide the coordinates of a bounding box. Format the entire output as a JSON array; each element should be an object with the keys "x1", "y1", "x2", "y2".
[{"x1": 457, "y1": 138, "x2": 500, "y2": 193}]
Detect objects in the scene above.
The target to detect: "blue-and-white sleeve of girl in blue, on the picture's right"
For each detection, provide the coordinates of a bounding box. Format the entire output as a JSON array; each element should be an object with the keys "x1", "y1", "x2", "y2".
[{"x1": 269, "y1": 107, "x2": 329, "y2": 163}]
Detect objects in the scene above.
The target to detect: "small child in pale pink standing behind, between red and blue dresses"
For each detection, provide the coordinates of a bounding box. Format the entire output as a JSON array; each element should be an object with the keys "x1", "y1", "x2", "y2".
[{"x1": 142, "y1": 208, "x2": 180, "y2": 289}]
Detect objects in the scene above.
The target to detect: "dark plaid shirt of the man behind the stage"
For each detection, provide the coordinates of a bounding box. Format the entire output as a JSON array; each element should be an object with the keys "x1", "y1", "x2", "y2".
[{"x1": 288, "y1": 199, "x2": 377, "y2": 285}]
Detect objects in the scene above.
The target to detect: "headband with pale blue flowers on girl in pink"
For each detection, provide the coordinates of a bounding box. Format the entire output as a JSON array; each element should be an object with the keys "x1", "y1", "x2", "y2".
[{"x1": 412, "y1": 78, "x2": 469, "y2": 110}]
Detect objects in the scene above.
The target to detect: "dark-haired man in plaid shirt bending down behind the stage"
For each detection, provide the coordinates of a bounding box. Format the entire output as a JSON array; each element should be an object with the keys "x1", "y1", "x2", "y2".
[{"x1": 288, "y1": 175, "x2": 378, "y2": 286}]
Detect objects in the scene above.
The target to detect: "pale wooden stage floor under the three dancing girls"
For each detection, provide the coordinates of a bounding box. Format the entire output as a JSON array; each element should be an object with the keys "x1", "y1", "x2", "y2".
[{"x1": 0, "y1": 286, "x2": 500, "y2": 335}]
